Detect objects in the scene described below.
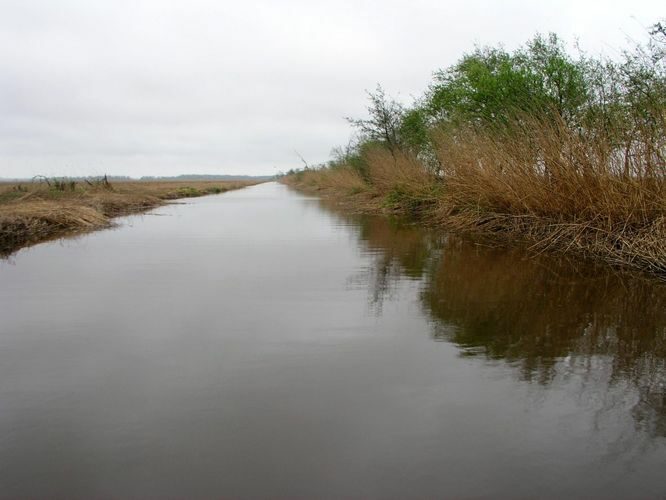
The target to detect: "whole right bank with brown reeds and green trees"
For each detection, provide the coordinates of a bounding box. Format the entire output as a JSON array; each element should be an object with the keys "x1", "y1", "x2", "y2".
[{"x1": 283, "y1": 29, "x2": 666, "y2": 276}]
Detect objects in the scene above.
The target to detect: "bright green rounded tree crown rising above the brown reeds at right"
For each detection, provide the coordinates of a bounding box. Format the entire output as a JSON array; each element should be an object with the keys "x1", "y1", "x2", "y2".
[{"x1": 426, "y1": 34, "x2": 587, "y2": 128}]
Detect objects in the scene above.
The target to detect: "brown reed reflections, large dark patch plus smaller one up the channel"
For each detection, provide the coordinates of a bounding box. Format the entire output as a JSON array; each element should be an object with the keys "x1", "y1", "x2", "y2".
[{"x1": 330, "y1": 203, "x2": 666, "y2": 377}]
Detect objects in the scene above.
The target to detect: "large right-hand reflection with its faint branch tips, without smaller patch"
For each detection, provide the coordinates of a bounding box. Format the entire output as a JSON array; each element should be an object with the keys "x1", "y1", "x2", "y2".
[{"x1": 422, "y1": 240, "x2": 666, "y2": 442}]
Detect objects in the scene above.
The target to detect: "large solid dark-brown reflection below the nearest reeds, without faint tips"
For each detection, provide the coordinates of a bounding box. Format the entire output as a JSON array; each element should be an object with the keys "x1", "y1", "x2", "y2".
[{"x1": 423, "y1": 238, "x2": 666, "y2": 375}]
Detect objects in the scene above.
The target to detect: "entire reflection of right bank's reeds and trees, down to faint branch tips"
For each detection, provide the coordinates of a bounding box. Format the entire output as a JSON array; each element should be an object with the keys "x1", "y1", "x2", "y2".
[{"x1": 322, "y1": 202, "x2": 666, "y2": 441}]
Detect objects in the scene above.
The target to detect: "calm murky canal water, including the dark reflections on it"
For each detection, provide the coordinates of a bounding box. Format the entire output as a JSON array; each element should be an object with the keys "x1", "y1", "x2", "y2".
[{"x1": 0, "y1": 183, "x2": 666, "y2": 498}]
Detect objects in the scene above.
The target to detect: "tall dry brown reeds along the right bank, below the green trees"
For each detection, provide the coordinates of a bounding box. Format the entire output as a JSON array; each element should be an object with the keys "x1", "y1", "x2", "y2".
[{"x1": 286, "y1": 117, "x2": 666, "y2": 275}]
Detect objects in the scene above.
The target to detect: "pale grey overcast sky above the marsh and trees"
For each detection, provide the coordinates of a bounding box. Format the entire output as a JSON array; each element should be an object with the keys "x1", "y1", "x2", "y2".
[{"x1": 0, "y1": 0, "x2": 664, "y2": 177}]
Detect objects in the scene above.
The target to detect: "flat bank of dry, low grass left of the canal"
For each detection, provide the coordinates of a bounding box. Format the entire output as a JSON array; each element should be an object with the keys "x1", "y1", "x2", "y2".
[{"x1": 0, "y1": 178, "x2": 255, "y2": 255}]
